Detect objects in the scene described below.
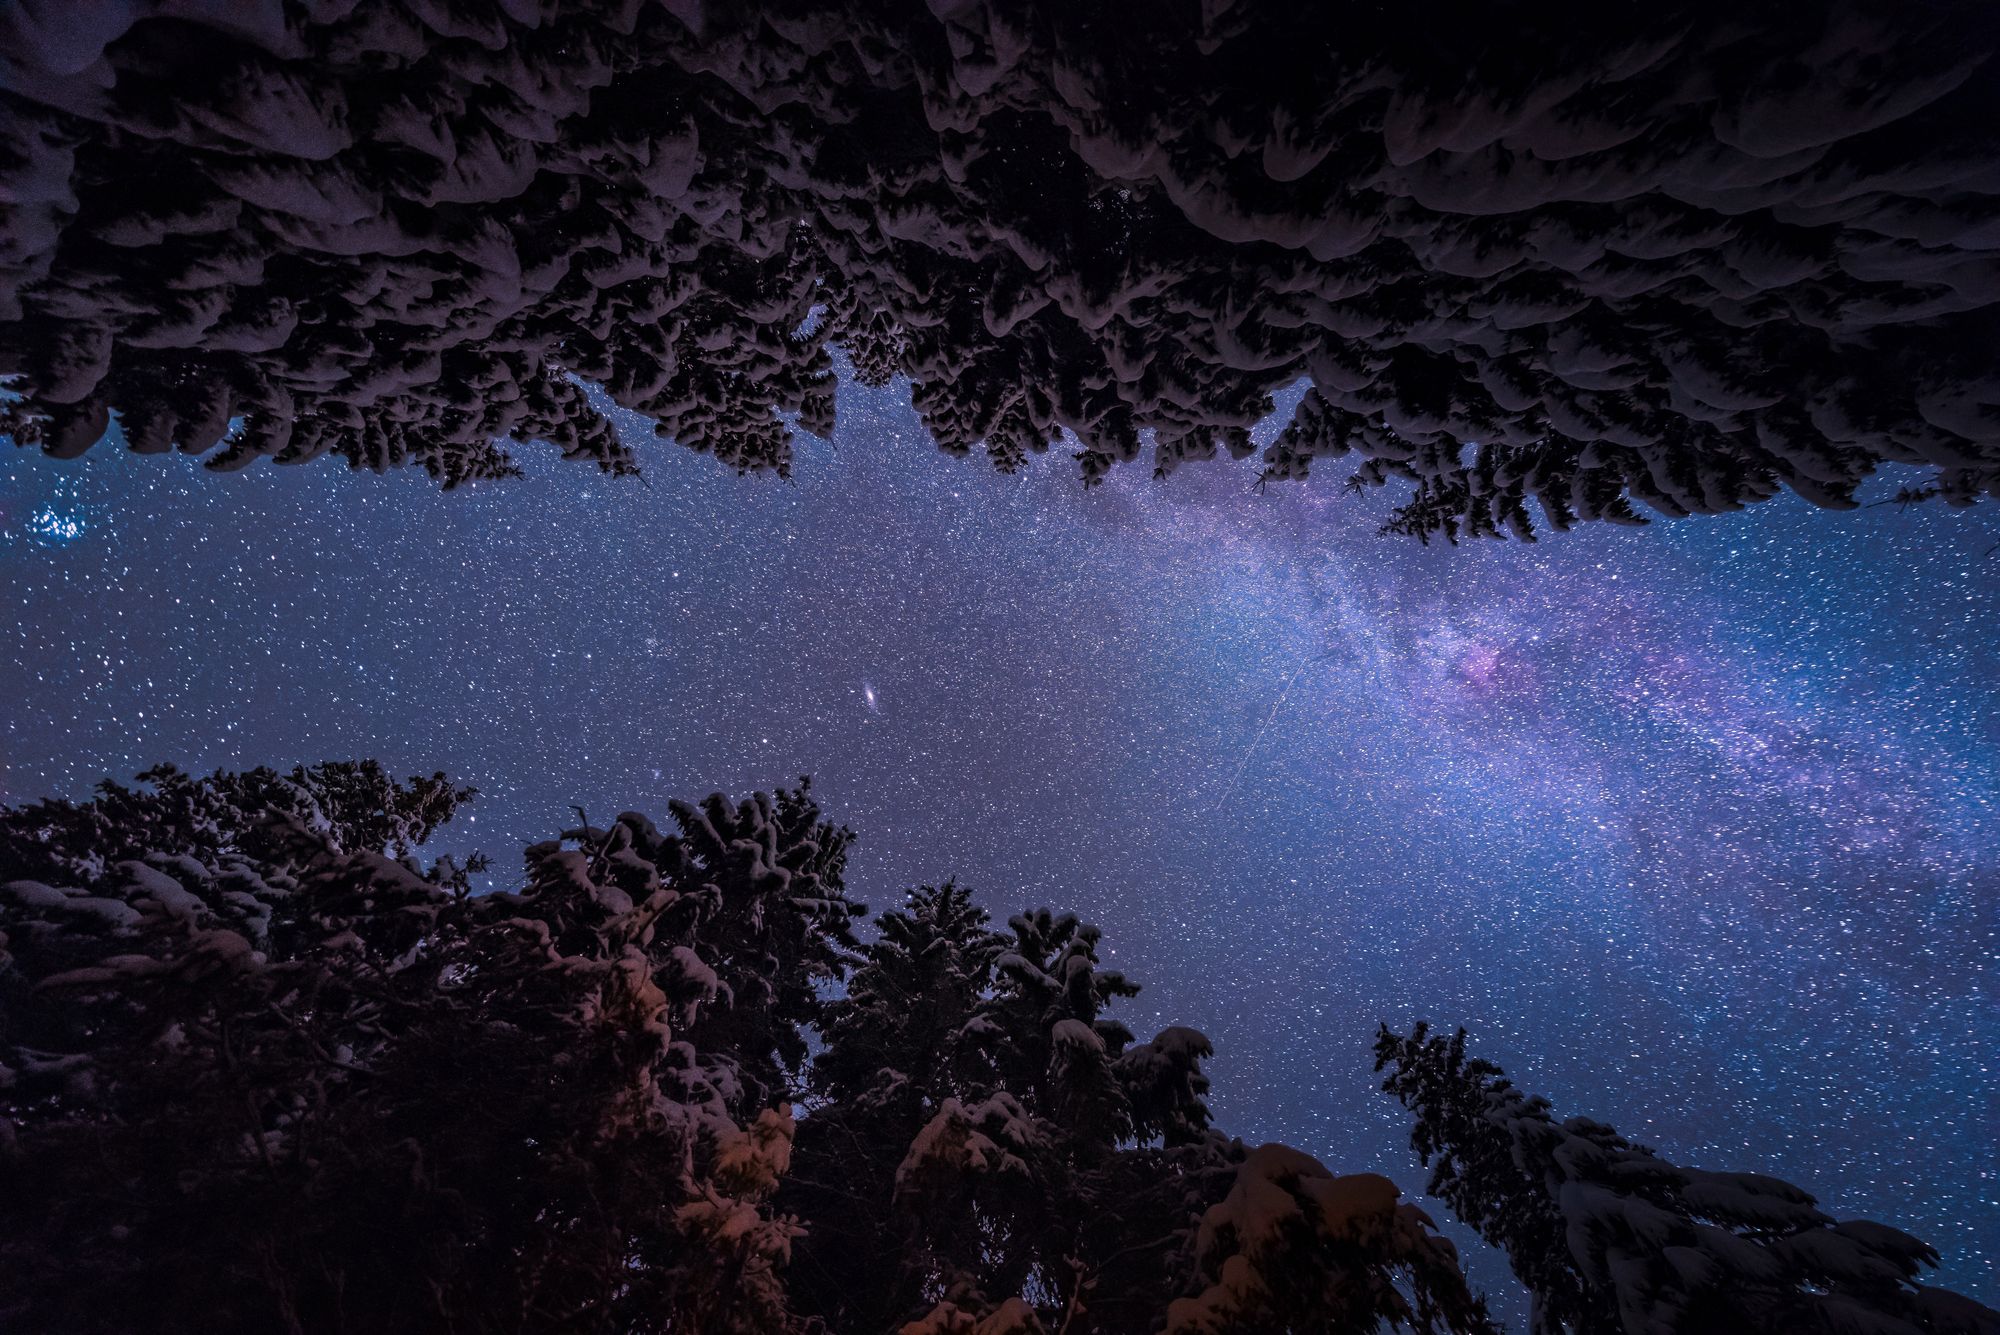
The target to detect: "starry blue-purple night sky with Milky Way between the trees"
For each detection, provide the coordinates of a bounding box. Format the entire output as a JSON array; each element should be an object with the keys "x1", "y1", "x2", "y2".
[{"x1": 0, "y1": 369, "x2": 2000, "y2": 1313}]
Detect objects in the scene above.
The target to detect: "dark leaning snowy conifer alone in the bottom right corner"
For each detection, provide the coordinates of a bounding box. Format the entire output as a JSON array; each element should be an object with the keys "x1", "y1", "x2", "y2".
[{"x1": 1376, "y1": 1025, "x2": 2000, "y2": 1335}]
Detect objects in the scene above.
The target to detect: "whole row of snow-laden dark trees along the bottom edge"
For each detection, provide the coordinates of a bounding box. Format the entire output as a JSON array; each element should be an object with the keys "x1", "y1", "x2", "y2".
[{"x1": 0, "y1": 761, "x2": 2000, "y2": 1335}]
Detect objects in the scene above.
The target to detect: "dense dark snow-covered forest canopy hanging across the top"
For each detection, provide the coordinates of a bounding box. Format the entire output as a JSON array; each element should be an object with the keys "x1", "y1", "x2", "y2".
[{"x1": 0, "y1": 0, "x2": 2000, "y2": 540}]
